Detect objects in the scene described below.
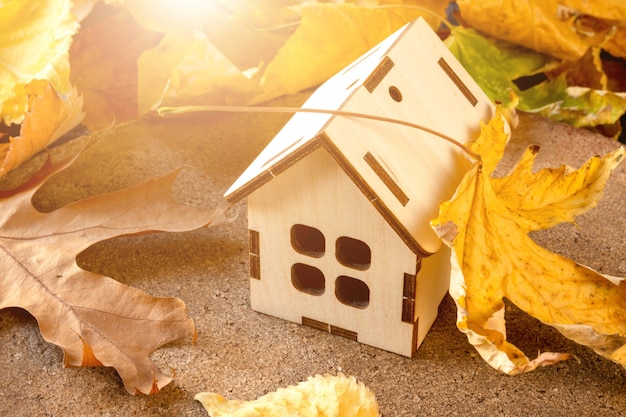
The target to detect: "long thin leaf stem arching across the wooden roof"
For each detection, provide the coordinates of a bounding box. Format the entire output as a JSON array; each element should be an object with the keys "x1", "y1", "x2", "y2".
[{"x1": 156, "y1": 105, "x2": 481, "y2": 164}]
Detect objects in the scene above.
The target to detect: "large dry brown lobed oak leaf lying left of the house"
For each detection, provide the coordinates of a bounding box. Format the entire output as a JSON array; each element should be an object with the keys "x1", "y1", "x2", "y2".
[{"x1": 0, "y1": 155, "x2": 225, "y2": 394}]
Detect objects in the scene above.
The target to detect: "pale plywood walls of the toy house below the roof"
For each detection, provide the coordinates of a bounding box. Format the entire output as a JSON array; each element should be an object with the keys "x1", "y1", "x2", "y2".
[{"x1": 248, "y1": 148, "x2": 448, "y2": 356}]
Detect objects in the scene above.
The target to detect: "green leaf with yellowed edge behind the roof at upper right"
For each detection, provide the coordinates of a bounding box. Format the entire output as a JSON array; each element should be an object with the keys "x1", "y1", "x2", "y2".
[{"x1": 447, "y1": 27, "x2": 626, "y2": 132}]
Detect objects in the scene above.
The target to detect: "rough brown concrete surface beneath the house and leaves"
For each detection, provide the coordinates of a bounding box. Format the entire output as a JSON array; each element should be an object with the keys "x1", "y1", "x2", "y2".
[{"x1": 0, "y1": 92, "x2": 626, "y2": 417}]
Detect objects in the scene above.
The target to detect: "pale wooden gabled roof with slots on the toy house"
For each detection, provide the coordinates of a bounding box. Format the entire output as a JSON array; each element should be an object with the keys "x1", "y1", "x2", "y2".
[{"x1": 224, "y1": 19, "x2": 493, "y2": 256}]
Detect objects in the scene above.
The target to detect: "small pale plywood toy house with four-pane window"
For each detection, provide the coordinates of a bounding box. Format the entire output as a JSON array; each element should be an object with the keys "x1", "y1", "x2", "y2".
[{"x1": 225, "y1": 19, "x2": 493, "y2": 356}]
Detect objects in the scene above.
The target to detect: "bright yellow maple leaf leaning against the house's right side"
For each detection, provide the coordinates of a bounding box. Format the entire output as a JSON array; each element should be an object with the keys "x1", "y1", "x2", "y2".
[{"x1": 432, "y1": 114, "x2": 626, "y2": 375}]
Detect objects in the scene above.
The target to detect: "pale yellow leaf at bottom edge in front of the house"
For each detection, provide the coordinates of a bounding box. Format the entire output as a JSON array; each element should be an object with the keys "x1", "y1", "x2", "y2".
[{"x1": 195, "y1": 374, "x2": 380, "y2": 417}]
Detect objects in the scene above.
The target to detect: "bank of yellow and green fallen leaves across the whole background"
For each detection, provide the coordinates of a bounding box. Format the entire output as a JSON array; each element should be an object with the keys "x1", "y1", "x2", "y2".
[{"x1": 0, "y1": 0, "x2": 626, "y2": 174}]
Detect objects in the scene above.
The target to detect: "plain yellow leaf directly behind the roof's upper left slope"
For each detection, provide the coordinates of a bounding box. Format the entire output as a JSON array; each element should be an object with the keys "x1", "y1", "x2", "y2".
[{"x1": 255, "y1": 3, "x2": 432, "y2": 102}]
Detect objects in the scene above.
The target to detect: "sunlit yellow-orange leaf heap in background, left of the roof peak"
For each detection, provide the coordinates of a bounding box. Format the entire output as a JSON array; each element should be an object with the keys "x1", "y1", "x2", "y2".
[{"x1": 0, "y1": 0, "x2": 454, "y2": 176}]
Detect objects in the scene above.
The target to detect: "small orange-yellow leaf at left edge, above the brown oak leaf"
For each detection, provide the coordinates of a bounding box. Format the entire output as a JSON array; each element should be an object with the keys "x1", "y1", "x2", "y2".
[{"x1": 0, "y1": 80, "x2": 84, "y2": 177}]
